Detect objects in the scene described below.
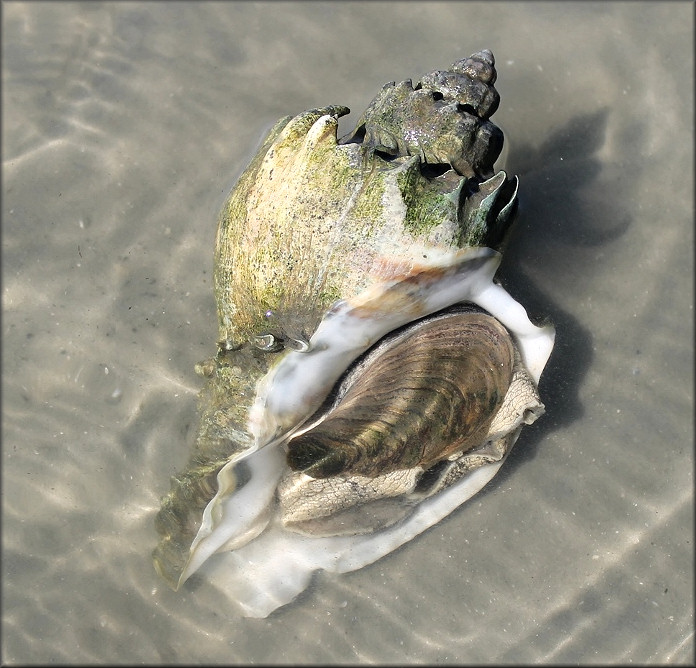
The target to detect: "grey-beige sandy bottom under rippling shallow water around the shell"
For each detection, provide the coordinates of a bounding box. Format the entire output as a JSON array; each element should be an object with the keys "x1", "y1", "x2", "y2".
[{"x1": 2, "y1": 2, "x2": 694, "y2": 664}]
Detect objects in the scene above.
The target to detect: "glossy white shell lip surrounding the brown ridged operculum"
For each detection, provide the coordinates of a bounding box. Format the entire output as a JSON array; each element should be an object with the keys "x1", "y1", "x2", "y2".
[{"x1": 179, "y1": 248, "x2": 555, "y2": 604}]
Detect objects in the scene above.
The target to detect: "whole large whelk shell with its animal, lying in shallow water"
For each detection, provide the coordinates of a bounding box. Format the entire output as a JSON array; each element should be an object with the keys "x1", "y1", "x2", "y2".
[{"x1": 154, "y1": 51, "x2": 554, "y2": 617}]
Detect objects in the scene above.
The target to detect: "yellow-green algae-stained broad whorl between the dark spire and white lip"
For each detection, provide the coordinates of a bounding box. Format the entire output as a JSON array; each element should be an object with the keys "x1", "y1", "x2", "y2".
[{"x1": 215, "y1": 107, "x2": 506, "y2": 345}]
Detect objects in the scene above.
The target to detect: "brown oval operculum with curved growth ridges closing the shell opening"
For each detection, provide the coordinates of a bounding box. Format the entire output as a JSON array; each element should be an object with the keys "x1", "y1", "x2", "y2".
[{"x1": 288, "y1": 312, "x2": 514, "y2": 478}]
